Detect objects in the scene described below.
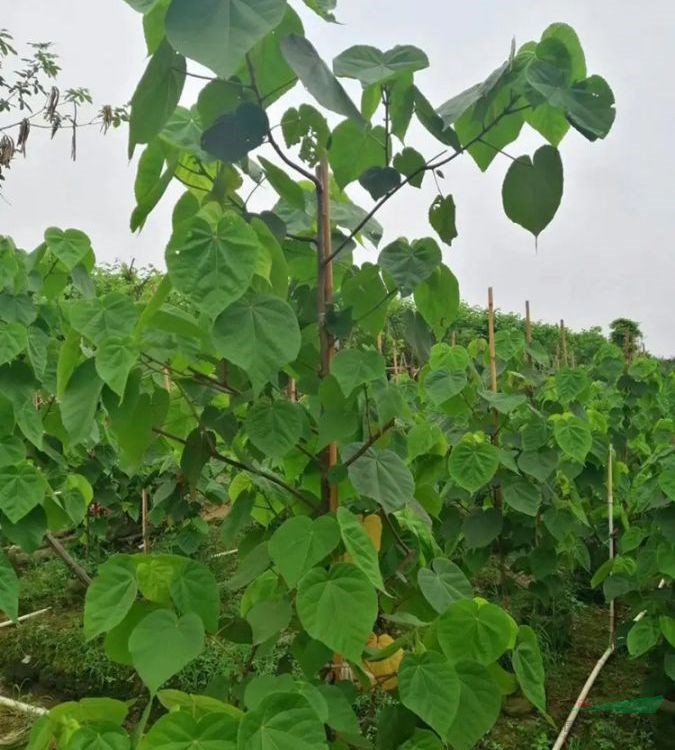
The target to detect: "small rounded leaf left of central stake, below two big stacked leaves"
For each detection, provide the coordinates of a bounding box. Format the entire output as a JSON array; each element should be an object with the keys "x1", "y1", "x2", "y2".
[{"x1": 244, "y1": 400, "x2": 304, "y2": 459}]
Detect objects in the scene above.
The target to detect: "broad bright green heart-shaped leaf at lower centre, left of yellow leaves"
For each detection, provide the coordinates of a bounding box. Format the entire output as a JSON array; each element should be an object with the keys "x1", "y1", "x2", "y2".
[{"x1": 296, "y1": 563, "x2": 377, "y2": 663}]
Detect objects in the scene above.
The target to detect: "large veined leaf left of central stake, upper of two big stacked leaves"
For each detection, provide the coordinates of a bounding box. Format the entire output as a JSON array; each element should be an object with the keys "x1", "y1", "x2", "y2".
[{"x1": 166, "y1": 212, "x2": 260, "y2": 318}]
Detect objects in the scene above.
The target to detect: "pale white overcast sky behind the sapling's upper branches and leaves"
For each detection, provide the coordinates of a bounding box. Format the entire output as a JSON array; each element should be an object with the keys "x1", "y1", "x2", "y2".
[{"x1": 0, "y1": 0, "x2": 675, "y2": 357}]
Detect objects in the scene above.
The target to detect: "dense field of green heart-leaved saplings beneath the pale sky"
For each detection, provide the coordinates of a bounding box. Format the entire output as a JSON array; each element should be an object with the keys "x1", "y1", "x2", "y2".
[{"x1": 0, "y1": 0, "x2": 675, "y2": 750}]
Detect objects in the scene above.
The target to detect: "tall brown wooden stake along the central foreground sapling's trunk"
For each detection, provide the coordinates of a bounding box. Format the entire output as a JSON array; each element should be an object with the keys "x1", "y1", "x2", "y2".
[{"x1": 317, "y1": 158, "x2": 338, "y2": 513}]
